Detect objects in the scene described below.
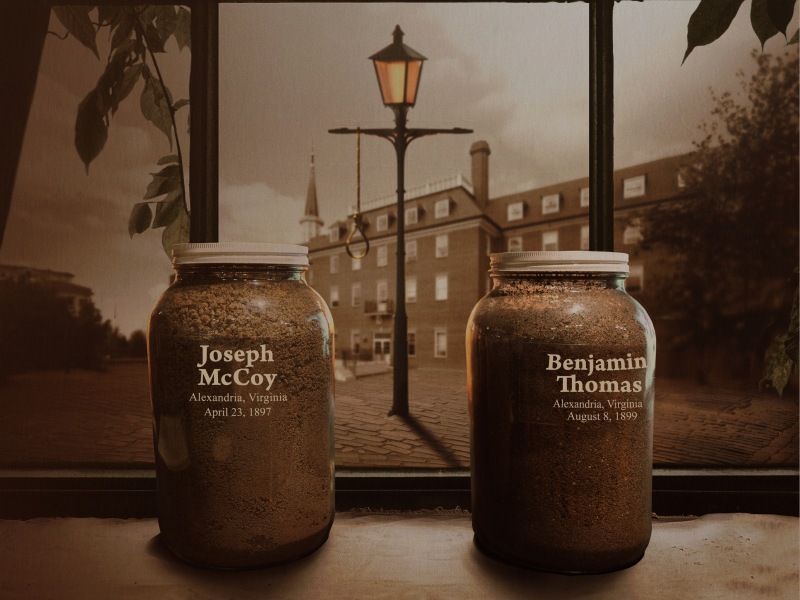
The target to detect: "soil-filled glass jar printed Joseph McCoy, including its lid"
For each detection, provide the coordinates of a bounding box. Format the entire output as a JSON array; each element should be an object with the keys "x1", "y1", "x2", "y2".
[{"x1": 147, "y1": 243, "x2": 334, "y2": 569}]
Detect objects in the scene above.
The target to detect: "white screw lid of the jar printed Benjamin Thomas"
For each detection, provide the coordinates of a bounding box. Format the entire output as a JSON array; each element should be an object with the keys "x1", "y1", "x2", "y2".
[{"x1": 491, "y1": 250, "x2": 628, "y2": 273}]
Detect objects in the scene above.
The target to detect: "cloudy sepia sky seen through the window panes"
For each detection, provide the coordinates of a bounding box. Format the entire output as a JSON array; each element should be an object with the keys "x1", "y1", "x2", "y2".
[{"x1": 0, "y1": 0, "x2": 798, "y2": 335}]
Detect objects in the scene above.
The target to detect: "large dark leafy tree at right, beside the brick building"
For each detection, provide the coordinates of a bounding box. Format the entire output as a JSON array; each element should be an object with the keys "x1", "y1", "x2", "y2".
[{"x1": 643, "y1": 51, "x2": 800, "y2": 392}]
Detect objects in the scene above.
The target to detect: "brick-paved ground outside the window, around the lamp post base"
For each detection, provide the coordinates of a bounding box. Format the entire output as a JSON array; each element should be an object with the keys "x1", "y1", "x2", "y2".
[{"x1": 0, "y1": 362, "x2": 800, "y2": 468}]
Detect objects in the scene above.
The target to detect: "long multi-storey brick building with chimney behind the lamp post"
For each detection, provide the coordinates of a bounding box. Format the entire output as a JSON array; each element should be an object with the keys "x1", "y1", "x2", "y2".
[{"x1": 301, "y1": 141, "x2": 686, "y2": 369}]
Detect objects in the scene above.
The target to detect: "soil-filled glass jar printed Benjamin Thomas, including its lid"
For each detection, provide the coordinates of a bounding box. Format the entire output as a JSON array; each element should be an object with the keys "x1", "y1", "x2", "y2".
[{"x1": 467, "y1": 252, "x2": 656, "y2": 573}]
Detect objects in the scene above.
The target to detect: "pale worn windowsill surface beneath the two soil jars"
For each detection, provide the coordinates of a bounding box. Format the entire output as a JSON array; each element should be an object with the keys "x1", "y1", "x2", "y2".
[{"x1": 0, "y1": 513, "x2": 800, "y2": 600}]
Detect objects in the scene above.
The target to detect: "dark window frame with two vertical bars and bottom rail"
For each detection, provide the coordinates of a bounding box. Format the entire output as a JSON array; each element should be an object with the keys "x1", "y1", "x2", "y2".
[{"x1": 0, "y1": 0, "x2": 800, "y2": 519}]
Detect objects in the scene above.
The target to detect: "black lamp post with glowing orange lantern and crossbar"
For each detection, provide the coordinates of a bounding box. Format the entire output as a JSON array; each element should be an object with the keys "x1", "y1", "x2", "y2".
[{"x1": 328, "y1": 25, "x2": 472, "y2": 416}]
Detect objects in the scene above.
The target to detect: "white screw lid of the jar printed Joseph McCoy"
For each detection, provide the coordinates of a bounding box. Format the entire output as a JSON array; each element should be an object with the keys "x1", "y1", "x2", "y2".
[{"x1": 172, "y1": 242, "x2": 308, "y2": 266}]
